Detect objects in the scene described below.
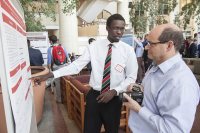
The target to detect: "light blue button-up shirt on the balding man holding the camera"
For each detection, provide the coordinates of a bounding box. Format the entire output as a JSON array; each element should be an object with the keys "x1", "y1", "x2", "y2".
[{"x1": 129, "y1": 54, "x2": 200, "y2": 133}]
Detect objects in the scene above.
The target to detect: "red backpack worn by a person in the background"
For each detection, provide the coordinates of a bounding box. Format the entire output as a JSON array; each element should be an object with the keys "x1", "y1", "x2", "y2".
[{"x1": 52, "y1": 45, "x2": 66, "y2": 65}]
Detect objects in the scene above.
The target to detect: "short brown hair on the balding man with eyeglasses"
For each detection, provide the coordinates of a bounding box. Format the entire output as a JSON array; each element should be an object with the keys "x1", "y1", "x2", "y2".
[{"x1": 158, "y1": 28, "x2": 184, "y2": 51}]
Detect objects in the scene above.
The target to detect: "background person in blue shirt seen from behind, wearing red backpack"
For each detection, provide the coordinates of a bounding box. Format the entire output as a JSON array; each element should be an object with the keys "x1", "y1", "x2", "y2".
[{"x1": 47, "y1": 35, "x2": 71, "y2": 102}]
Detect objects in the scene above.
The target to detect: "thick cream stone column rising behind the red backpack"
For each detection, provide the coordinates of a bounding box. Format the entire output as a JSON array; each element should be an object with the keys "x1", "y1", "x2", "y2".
[{"x1": 59, "y1": 0, "x2": 78, "y2": 54}]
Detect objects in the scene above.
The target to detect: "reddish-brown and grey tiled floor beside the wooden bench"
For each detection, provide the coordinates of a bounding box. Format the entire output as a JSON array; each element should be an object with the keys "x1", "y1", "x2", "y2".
[{"x1": 38, "y1": 89, "x2": 200, "y2": 133}]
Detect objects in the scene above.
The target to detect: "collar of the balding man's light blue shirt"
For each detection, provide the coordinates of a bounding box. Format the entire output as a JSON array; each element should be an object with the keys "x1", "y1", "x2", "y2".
[{"x1": 158, "y1": 53, "x2": 181, "y2": 73}]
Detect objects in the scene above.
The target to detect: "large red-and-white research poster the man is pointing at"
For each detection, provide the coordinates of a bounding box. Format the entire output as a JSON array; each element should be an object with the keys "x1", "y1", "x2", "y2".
[{"x1": 0, "y1": 0, "x2": 33, "y2": 133}]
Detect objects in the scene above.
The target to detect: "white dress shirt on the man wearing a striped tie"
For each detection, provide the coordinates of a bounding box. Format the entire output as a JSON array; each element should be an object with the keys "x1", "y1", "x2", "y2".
[{"x1": 53, "y1": 39, "x2": 138, "y2": 94}]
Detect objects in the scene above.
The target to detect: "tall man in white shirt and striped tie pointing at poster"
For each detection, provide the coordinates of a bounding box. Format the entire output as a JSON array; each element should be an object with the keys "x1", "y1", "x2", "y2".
[{"x1": 35, "y1": 14, "x2": 138, "y2": 133}]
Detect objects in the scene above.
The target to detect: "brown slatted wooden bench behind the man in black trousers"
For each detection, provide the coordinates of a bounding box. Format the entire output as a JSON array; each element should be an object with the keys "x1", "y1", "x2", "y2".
[{"x1": 65, "y1": 76, "x2": 129, "y2": 133}]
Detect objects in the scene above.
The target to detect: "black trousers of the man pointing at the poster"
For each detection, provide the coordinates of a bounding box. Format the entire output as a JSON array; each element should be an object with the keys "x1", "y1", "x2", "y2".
[{"x1": 84, "y1": 89, "x2": 122, "y2": 133}]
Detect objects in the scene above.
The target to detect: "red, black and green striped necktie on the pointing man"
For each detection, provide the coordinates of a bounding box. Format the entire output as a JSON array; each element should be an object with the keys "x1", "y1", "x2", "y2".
[{"x1": 101, "y1": 44, "x2": 113, "y2": 93}]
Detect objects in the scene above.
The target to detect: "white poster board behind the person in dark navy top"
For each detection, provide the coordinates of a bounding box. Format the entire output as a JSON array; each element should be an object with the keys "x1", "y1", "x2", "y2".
[{"x1": 27, "y1": 32, "x2": 50, "y2": 65}]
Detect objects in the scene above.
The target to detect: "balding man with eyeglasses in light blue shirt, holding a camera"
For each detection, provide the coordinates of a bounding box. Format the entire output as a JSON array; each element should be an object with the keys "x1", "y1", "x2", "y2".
[{"x1": 124, "y1": 24, "x2": 200, "y2": 133}]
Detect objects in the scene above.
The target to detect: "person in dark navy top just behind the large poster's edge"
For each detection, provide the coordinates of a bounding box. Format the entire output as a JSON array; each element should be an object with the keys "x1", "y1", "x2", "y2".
[{"x1": 27, "y1": 40, "x2": 44, "y2": 66}]
